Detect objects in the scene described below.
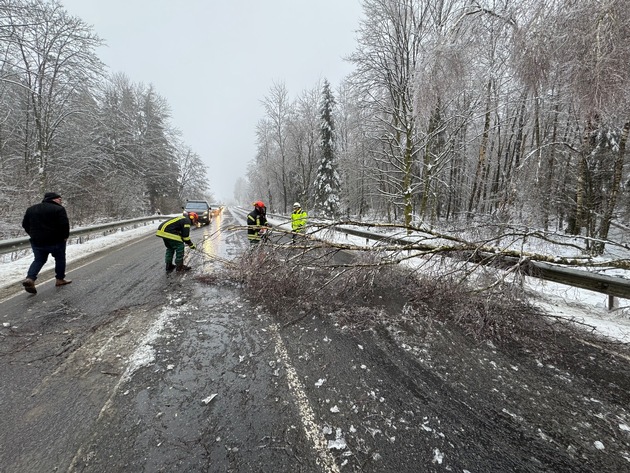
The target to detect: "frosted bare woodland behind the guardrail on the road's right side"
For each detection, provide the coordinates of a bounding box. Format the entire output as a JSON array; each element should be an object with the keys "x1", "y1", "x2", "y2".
[{"x1": 244, "y1": 0, "x2": 630, "y2": 254}]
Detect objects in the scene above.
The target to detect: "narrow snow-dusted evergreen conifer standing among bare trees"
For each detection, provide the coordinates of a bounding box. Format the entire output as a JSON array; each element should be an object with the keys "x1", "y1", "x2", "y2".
[{"x1": 315, "y1": 79, "x2": 341, "y2": 218}]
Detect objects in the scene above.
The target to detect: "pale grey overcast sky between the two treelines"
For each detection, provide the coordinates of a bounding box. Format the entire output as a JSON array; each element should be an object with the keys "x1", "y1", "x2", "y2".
[{"x1": 61, "y1": 0, "x2": 362, "y2": 201}]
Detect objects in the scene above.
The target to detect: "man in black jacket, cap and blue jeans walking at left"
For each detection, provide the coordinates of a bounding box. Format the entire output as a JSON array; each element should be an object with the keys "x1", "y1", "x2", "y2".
[{"x1": 22, "y1": 192, "x2": 72, "y2": 294}]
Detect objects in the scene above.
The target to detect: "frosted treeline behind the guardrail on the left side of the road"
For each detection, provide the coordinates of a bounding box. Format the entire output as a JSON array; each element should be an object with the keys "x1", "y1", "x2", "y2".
[{"x1": 0, "y1": 0, "x2": 208, "y2": 238}]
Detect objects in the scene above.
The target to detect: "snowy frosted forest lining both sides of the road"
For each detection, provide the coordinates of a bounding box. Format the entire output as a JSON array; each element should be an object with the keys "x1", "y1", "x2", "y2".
[{"x1": 0, "y1": 0, "x2": 630, "y2": 254}]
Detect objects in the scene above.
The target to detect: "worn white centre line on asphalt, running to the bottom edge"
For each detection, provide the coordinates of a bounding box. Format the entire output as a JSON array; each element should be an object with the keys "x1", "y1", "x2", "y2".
[{"x1": 271, "y1": 324, "x2": 341, "y2": 473}]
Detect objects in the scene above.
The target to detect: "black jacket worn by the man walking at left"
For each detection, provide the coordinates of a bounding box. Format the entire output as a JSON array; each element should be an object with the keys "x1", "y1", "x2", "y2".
[{"x1": 22, "y1": 198, "x2": 70, "y2": 246}]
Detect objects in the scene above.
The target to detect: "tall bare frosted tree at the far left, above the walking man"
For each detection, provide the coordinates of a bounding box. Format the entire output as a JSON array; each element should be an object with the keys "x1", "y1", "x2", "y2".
[{"x1": 0, "y1": 0, "x2": 103, "y2": 194}]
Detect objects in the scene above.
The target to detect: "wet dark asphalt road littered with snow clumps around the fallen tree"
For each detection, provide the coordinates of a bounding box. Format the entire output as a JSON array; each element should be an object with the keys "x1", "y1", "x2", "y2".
[{"x1": 0, "y1": 210, "x2": 630, "y2": 473}]
